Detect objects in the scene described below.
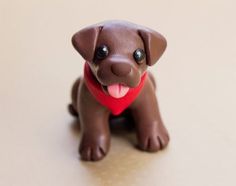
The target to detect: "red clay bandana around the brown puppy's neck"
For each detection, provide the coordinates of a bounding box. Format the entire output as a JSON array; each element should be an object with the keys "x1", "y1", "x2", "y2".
[{"x1": 84, "y1": 62, "x2": 147, "y2": 115}]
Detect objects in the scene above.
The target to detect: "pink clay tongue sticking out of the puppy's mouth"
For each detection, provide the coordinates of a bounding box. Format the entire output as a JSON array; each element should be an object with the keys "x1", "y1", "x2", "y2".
[{"x1": 107, "y1": 84, "x2": 129, "y2": 98}]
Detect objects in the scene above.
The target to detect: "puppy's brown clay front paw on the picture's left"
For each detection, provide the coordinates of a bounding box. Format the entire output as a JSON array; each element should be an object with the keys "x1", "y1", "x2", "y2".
[{"x1": 79, "y1": 136, "x2": 109, "y2": 161}]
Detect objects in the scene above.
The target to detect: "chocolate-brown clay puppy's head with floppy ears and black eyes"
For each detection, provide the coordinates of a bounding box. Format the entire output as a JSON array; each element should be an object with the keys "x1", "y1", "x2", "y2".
[{"x1": 72, "y1": 21, "x2": 167, "y2": 97}]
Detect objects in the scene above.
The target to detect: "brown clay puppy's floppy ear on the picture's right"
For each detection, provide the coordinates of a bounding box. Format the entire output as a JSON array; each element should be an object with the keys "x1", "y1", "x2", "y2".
[{"x1": 138, "y1": 28, "x2": 167, "y2": 66}]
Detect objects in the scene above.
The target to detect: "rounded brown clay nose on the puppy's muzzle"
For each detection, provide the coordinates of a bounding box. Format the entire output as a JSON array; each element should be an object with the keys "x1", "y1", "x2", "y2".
[{"x1": 111, "y1": 63, "x2": 131, "y2": 76}]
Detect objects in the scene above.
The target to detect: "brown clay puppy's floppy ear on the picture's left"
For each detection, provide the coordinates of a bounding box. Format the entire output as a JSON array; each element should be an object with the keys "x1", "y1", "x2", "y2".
[{"x1": 71, "y1": 25, "x2": 102, "y2": 62}]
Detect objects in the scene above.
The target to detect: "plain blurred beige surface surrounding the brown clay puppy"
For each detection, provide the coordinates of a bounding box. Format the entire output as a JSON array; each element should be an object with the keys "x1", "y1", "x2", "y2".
[{"x1": 0, "y1": 0, "x2": 236, "y2": 186}]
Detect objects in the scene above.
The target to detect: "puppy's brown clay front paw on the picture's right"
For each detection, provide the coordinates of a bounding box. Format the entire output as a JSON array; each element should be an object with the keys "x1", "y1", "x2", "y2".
[{"x1": 138, "y1": 125, "x2": 170, "y2": 152}]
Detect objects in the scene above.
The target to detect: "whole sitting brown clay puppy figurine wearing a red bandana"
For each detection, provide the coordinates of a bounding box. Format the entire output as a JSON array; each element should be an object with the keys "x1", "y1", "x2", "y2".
[{"x1": 69, "y1": 21, "x2": 169, "y2": 161}]
